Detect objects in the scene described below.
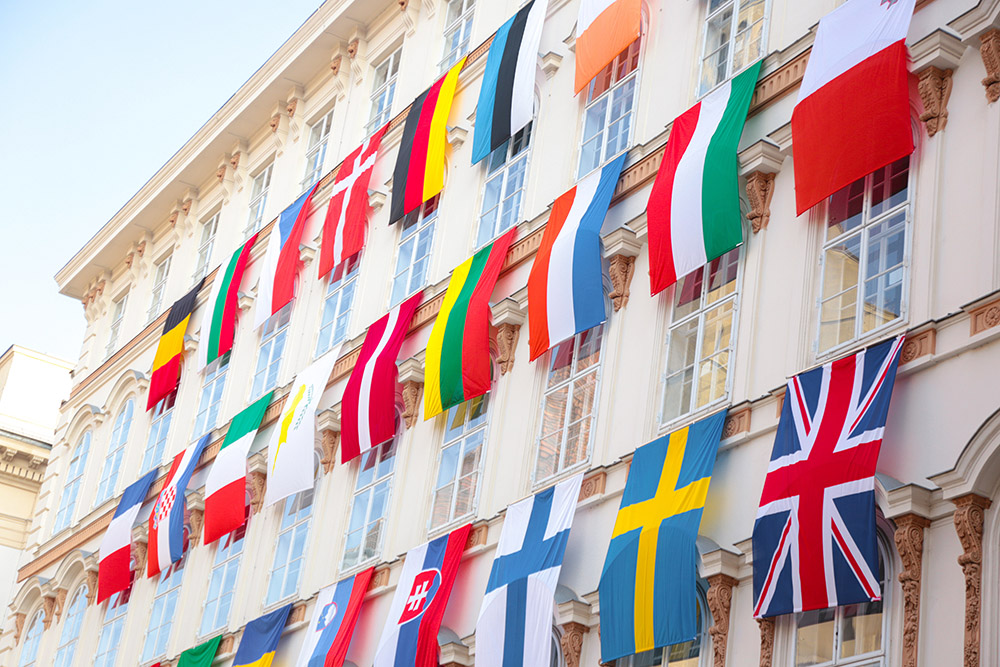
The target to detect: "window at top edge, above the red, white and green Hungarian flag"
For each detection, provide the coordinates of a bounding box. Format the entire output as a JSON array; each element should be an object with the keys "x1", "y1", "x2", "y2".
[{"x1": 698, "y1": 0, "x2": 767, "y2": 96}]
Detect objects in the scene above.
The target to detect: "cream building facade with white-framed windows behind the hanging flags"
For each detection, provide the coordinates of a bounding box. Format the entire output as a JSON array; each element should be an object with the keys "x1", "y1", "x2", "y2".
[{"x1": 0, "y1": 0, "x2": 1000, "y2": 667}]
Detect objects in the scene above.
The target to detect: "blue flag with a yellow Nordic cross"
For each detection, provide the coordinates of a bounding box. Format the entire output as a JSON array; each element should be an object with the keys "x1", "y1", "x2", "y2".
[{"x1": 598, "y1": 412, "x2": 726, "y2": 662}]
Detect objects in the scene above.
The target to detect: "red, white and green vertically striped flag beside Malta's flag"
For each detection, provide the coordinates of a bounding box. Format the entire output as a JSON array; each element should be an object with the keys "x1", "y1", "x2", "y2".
[{"x1": 646, "y1": 63, "x2": 760, "y2": 294}]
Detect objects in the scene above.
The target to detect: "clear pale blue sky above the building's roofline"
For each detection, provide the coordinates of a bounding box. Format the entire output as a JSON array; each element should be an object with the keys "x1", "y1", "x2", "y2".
[{"x1": 0, "y1": 0, "x2": 321, "y2": 362}]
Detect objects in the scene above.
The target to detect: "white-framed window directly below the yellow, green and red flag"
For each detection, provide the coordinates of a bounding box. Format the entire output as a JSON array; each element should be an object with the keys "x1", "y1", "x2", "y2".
[{"x1": 430, "y1": 394, "x2": 489, "y2": 530}]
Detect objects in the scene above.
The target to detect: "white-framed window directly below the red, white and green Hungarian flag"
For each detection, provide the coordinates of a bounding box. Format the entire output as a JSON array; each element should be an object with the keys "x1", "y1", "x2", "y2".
[{"x1": 660, "y1": 248, "x2": 740, "y2": 423}]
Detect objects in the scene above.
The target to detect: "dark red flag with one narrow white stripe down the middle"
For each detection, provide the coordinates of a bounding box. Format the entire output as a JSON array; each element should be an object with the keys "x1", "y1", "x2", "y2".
[{"x1": 340, "y1": 291, "x2": 423, "y2": 463}]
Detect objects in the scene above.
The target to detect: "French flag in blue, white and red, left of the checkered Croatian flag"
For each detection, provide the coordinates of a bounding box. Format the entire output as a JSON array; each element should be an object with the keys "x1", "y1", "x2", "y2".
[{"x1": 97, "y1": 470, "x2": 156, "y2": 604}]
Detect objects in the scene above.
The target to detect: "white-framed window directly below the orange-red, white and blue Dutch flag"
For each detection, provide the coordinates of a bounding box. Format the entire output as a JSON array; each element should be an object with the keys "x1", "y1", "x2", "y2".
[{"x1": 535, "y1": 325, "x2": 603, "y2": 483}]
